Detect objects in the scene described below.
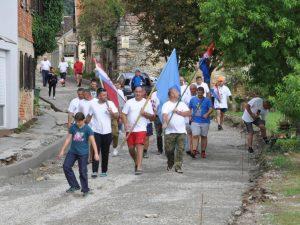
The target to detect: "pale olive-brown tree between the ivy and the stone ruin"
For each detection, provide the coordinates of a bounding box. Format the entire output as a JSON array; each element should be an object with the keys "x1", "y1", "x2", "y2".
[{"x1": 78, "y1": 0, "x2": 124, "y2": 50}]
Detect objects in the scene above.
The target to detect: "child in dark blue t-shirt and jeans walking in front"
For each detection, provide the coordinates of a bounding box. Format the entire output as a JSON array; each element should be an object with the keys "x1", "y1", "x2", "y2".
[{"x1": 57, "y1": 112, "x2": 99, "y2": 197}]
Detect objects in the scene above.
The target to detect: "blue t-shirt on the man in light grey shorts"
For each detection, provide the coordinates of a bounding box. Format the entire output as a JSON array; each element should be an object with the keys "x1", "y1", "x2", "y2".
[{"x1": 189, "y1": 97, "x2": 212, "y2": 123}]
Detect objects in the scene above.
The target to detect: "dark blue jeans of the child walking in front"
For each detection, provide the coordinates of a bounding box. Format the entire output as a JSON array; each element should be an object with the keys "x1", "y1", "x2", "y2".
[{"x1": 63, "y1": 152, "x2": 89, "y2": 192}]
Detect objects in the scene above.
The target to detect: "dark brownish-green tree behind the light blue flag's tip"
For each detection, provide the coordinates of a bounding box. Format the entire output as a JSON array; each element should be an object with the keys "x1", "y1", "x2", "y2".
[{"x1": 126, "y1": 0, "x2": 200, "y2": 67}]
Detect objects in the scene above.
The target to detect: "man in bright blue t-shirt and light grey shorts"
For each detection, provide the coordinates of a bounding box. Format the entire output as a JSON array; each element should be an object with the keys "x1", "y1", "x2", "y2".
[{"x1": 189, "y1": 87, "x2": 213, "y2": 158}]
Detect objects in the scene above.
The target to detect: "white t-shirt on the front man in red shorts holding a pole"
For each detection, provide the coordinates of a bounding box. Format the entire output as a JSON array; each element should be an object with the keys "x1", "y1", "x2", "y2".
[{"x1": 122, "y1": 98, "x2": 154, "y2": 132}]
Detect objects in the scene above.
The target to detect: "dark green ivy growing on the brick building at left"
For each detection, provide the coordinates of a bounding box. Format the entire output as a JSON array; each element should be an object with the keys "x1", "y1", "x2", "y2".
[{"x1": 32, "y1": 0, "x2": 63, "y2": 56}]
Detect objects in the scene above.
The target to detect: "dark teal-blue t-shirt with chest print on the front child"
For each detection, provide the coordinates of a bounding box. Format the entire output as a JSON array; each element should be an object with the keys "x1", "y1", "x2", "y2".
[{"x1": 69, "y1": 124, "x2": 94, "y2": 155}]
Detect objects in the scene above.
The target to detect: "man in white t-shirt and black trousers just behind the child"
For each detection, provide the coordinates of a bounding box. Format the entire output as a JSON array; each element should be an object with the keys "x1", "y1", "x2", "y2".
[{"x1": 86, "y1": 88, "x2": 119, "y2": 178}]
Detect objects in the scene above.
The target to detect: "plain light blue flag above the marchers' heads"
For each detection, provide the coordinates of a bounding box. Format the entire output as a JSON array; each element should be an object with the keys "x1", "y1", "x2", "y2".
[{"x1": 156, "y1": 49, "x2": 180, "y2": 121}]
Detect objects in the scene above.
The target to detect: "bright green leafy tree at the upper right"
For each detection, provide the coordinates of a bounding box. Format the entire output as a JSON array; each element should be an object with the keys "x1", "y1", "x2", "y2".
[{"x1": 198, "y1": 0, "x2": 300, "y2": 94}]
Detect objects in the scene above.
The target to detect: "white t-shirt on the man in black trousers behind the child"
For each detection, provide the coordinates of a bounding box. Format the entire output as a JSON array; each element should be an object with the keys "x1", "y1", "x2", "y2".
[{"x1": 88, "y1": 101, "x2": 118, "y2": 134}]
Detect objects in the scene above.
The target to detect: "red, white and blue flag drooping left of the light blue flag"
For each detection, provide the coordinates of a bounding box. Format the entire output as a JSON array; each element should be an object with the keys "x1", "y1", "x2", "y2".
[{"x1": 94, "y1": 59, "x2": 126, "y2": 108}]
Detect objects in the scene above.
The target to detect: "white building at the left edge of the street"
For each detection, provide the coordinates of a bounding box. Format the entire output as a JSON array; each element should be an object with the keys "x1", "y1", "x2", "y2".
[{"x1": 0, "y1": 0, "x2": 19, "y2": 130}]
